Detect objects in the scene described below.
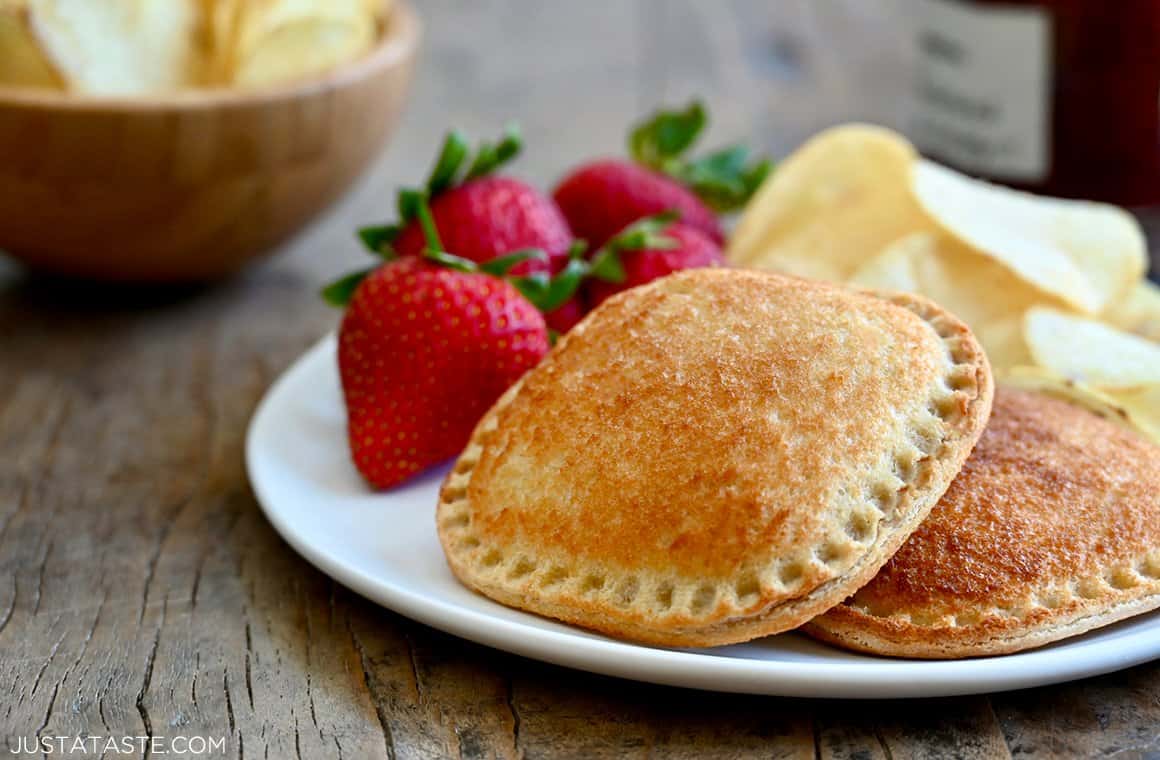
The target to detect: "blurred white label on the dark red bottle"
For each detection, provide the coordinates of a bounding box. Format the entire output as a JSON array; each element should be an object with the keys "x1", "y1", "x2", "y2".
[{"x1": 911, "y1": 0, "x2": 1051, "y2": 182}]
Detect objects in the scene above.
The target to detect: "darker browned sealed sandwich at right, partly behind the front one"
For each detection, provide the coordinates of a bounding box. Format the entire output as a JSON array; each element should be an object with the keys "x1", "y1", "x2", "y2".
[{"x1": 806, "y1": 388, "x2": 1160, "y2": 658}]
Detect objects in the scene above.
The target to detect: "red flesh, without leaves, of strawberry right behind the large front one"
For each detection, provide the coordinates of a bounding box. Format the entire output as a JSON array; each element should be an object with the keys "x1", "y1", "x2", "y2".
[{"x1": 391, "y1": 176, "x2": 572, "y2": 274}]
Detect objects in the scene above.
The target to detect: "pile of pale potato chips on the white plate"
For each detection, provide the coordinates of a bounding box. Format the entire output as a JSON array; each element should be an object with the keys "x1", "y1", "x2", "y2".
[{"x1": 728, "y1": 124, "x2": 1160, "y2": 441}]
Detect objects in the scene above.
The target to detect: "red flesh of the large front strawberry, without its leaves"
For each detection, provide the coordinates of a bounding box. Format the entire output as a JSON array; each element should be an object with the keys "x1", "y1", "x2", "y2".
[{"x1": 339, "y1": 256, "x2": 549, "y2": 488}]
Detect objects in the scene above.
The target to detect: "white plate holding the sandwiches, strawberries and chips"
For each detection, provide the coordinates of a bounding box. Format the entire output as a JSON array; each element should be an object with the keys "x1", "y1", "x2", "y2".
[{"x1": 246, "y1": 336, "x2": 1160, "y2": 697}]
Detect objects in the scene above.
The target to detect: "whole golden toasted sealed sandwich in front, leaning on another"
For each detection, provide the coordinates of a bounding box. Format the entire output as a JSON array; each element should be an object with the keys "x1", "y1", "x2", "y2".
[{"x1": 437, "y1": 269, "x2": 992, "y2": 646}]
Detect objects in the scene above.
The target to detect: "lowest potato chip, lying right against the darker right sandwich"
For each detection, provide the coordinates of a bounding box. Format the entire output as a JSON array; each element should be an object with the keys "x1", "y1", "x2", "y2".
[{"x1": 999, "y1": 367, "x2": 1160, "y2": 443}]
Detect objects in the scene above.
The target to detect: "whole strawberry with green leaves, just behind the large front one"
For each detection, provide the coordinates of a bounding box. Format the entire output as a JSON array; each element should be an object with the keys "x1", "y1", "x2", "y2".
[{"x1": 361, "y1": 126, "x2": 572, "y2": 274}]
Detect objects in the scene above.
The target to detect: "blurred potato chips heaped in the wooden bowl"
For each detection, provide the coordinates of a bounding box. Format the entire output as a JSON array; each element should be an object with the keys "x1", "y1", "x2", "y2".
[{"x1": 0, "y1": 0, "x2": 390, "y2": 95}]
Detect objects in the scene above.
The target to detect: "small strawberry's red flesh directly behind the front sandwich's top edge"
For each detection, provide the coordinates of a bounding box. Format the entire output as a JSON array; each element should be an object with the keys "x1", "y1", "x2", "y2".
[{"x1": 586, "y1": 220, "x2": 725, "y2": 307}]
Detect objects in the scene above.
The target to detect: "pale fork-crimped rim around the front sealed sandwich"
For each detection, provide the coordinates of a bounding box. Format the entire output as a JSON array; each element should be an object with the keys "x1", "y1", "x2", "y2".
[{"x1": 437, "y1": 272, "x2": 992, "y2": 646}]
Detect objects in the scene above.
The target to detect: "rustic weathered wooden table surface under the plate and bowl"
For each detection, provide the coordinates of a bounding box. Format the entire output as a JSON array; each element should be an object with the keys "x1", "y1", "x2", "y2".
[{"x1": 0, "y1": 0, "x2": 1160, "y2": 760}]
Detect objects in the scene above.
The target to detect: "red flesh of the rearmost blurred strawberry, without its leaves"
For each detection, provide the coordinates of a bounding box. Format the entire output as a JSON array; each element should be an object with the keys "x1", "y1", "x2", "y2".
[{"x1": 552, "y1": 159, "x2": 725, "y2": 246}]
